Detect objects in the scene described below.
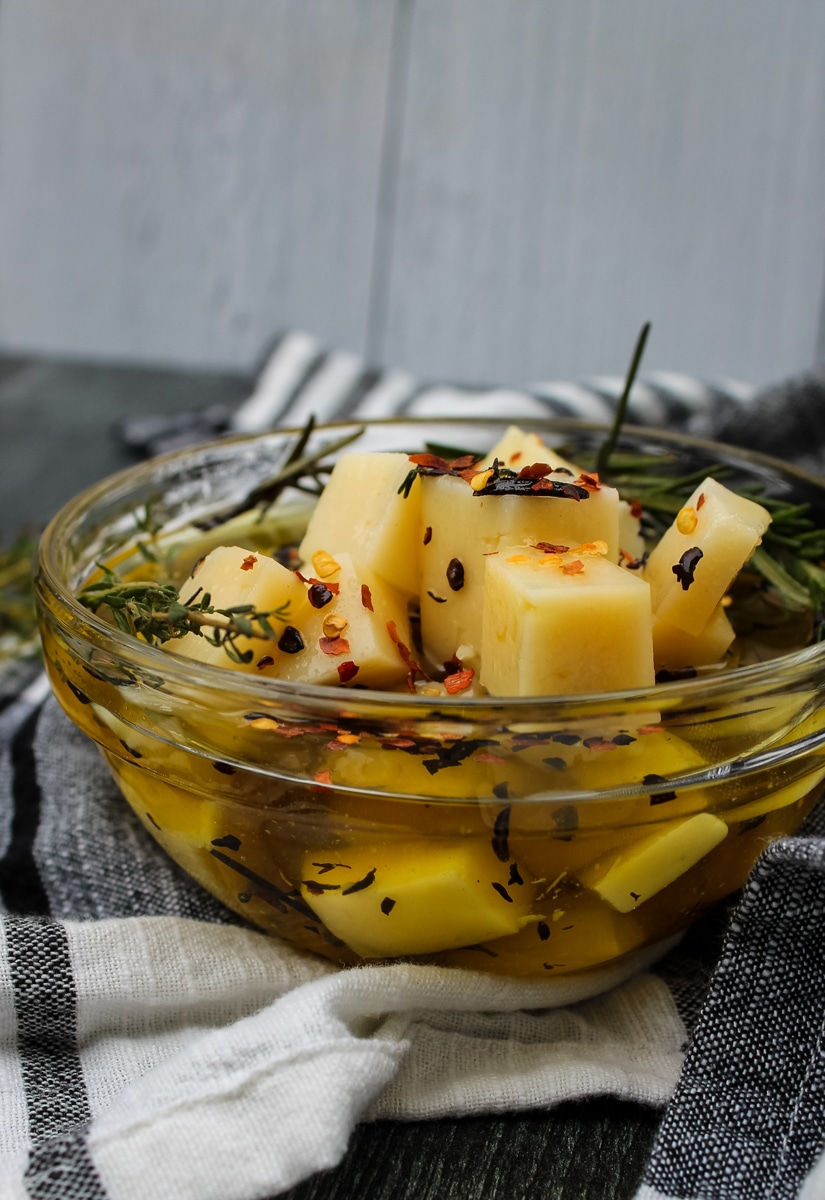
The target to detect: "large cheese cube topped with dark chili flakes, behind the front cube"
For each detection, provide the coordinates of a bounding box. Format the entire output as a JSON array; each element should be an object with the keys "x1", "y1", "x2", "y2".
[{"x1": 420, "y1": 475, "x2": 619, "y2": 665}]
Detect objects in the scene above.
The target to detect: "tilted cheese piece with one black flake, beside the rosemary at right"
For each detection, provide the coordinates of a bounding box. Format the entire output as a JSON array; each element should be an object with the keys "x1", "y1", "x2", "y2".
[{"x1": 644, "y1": 478, "x2": 771, "y2": 634}]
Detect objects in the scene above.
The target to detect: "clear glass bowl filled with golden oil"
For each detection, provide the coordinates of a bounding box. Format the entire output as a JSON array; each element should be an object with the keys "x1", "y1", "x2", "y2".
[{"x1": 36, "y1": 420, "x2": 825, "y2": 978}]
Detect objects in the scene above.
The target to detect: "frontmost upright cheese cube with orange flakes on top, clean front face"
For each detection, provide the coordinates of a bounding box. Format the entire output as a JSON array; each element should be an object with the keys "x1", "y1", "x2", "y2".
[{"x1": 481, "y1": 547, "x2": 655, "y2": 696}]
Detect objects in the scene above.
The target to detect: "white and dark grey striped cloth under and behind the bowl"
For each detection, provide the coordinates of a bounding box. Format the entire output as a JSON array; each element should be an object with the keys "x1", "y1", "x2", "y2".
[{"x1": 0, "y1": 334, "x2": 825, "y2": 1200}]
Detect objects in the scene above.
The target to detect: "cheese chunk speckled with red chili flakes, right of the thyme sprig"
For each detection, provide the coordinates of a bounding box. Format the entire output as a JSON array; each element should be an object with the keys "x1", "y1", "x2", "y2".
[{"x1": 273, "y1": 551, "x2": 411, "y2": 688}]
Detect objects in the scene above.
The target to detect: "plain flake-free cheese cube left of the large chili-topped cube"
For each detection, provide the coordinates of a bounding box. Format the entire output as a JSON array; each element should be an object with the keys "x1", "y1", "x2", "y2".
[{"x1": 299, "y1": 451, "x2": 420, "y2": 596}]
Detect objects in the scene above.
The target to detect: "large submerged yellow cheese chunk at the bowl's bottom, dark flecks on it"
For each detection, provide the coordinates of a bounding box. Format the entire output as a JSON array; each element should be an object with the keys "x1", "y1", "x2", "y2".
[{"x1": 301, "y1": 839, "x2": 536, "y2": 959}]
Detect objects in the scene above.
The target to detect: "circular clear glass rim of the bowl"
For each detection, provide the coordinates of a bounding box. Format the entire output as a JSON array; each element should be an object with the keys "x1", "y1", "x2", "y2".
[{"x1": 34, "y1": 414, "x2": 825, "y2": 719}]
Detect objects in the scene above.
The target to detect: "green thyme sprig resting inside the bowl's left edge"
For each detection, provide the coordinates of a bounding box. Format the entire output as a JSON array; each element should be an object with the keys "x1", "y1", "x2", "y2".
[{"x1": 78, "y1": 563, "x2": 290, "y2": 662}]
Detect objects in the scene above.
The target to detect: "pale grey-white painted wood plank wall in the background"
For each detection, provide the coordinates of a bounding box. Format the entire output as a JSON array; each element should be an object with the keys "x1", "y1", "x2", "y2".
[{"x1": 0, "y1": 0, "x2": 825, "y2": 384}]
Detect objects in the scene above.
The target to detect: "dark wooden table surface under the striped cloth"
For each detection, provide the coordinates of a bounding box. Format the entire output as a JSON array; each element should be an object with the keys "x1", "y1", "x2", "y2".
[{"x1": 0, "y1": 358, "x2": 661, "y2": 1200}]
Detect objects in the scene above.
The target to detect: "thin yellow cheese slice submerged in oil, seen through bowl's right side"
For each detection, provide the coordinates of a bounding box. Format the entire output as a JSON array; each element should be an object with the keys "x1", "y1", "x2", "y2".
[{"x1": 577, "y1": 812, "x2": 728, "y2": 912}]
